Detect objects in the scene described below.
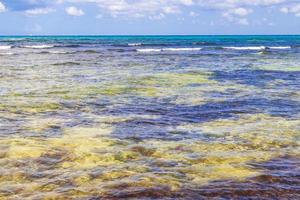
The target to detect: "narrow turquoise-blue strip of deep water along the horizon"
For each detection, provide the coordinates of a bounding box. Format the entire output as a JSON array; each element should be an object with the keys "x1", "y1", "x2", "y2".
[{"x1": 0, "y1": 35, "x2": 300, "y2": 46}]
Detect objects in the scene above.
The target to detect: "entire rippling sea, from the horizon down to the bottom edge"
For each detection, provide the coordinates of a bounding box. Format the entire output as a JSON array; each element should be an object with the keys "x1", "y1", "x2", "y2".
[{"x1": 0, "y1": 36, "x2": 300, "y2": 199}]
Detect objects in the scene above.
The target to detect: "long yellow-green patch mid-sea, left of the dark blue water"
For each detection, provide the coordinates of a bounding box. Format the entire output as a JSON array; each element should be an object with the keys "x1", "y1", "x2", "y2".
[{"x1": 56, "y1": 72, "x2": 215, "y2": 99}]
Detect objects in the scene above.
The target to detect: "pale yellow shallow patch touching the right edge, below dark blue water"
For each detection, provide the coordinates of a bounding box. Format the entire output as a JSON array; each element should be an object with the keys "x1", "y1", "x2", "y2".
[{"x1": 201, "y1": 114, "x2": 300, "y2": 149}]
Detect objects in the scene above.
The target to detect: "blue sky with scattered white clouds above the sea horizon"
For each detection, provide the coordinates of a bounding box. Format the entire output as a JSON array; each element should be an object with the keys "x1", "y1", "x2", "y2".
[{"x1": 0, "y1": 0, "x2": 300, "y2": 35}]
